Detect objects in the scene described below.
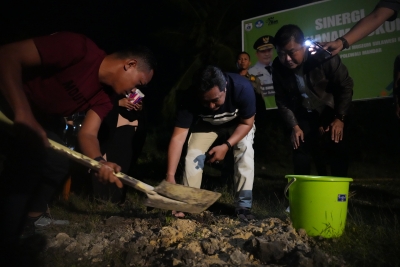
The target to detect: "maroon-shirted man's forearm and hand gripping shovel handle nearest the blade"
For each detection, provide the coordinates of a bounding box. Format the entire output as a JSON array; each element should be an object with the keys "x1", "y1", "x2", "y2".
[{"x1": 78, "y1": 110, "x2": 122, "y2": 188}]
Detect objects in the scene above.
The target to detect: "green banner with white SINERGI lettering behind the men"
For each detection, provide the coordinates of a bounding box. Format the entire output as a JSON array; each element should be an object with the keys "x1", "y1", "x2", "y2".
[{"x1": 242, "y1": 0, "x2": 400, "y2": 109}]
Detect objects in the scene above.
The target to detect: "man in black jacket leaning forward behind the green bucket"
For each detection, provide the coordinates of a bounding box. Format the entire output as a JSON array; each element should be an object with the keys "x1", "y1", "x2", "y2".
[{"x1": 272, "y1": 25, "x2": 353, "y2": 177}]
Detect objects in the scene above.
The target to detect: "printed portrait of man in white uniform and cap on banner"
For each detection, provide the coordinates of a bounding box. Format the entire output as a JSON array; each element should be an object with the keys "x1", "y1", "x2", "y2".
[{"x1": 248, "y1": 35, "x2": 275, "y2": 96}]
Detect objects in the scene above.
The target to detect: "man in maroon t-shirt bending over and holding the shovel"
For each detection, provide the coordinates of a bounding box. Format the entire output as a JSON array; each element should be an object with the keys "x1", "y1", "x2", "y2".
[{"x1": 0, "y1": 32, "x2": 156, "y2": 266}]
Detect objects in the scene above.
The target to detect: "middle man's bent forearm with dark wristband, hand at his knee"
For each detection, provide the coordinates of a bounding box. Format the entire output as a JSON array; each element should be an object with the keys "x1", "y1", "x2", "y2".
[{"x1": 208, "y1": 115, "x2": 254, "y2": 163}]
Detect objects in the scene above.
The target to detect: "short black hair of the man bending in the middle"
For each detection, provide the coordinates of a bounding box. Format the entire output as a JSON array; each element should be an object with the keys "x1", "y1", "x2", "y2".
[{"x1": 193, "y1": 65, "x2": 226, "y2": 93}]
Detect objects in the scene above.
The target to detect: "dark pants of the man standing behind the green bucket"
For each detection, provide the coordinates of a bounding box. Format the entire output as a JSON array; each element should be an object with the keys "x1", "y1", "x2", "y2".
[{"x1": 293, "y1": 108, "x2": 348, "y2": 177}]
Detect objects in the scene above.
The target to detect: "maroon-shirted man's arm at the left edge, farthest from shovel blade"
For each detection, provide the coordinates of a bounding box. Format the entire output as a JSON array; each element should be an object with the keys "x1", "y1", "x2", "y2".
[{"x1": 0, "y1": 39, "x2": 48, "y2": 145}]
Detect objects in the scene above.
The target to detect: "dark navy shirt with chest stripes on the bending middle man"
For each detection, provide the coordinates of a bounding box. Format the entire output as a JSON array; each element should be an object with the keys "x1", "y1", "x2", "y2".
[{"x1": 175, "y1": 73, "x2": 256, "y2": 128}]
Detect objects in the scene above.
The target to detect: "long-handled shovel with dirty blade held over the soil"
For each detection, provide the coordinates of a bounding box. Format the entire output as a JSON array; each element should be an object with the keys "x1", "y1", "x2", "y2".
[{"x1": 0, "y1": 111, "x2": 221, "y2": 213}]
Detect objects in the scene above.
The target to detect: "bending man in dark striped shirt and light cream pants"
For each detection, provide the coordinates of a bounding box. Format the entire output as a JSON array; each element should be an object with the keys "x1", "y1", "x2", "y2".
[{"x1": 166, "y1": 66, "x2": 256, "y2": 220}]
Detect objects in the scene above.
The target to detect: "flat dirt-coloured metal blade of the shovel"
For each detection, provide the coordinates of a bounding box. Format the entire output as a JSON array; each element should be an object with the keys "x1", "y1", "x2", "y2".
[{"x1": 145, "y1": 180, "x2": 221, "y2": 213}]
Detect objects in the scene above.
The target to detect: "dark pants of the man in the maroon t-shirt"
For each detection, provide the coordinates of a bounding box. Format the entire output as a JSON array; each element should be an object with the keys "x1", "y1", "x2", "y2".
[{"x1": 0, "y1": 117, "x2": 69, "y2": 249}]
